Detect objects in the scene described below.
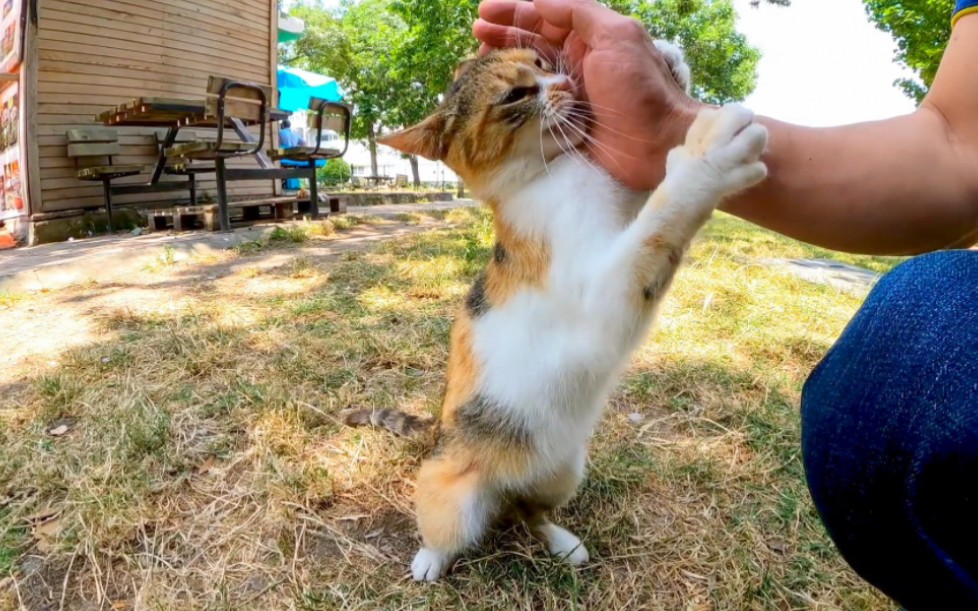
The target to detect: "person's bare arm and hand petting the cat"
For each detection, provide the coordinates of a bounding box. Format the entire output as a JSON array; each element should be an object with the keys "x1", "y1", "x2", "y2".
[{"x1": 475, "y1": 0, "x2": 978, "y2": 254}]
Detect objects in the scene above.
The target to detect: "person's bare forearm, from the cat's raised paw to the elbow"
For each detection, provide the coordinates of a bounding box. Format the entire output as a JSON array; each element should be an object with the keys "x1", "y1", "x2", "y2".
[{"x1": 725, "y1": 108, "x2": 978, "y2": 254}]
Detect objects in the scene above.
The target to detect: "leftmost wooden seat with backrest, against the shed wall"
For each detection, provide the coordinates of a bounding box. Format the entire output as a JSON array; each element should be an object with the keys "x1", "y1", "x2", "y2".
[{"x1": 65, "y1": 127, "x2": 145, "y2": 233}]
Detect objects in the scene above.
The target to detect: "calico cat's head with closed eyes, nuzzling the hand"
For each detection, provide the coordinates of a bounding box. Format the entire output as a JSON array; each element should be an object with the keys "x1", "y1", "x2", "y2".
[{"x1": 379, "y1": 49, "x2": 584, "y2": 196}]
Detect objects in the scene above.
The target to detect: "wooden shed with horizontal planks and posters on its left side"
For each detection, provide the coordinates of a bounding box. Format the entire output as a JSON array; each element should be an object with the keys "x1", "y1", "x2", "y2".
[{"x1": 0, "y1": 0, "x2": 279, "y2": 242}]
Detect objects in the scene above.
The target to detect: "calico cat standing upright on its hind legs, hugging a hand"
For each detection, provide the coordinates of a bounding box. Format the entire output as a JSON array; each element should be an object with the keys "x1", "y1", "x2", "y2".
[{"x1": 347, "y1": 43, "x2": 767, "y2": 581}]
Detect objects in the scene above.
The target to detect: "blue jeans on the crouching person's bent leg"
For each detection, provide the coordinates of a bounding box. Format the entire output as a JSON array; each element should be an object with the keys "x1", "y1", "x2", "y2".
[{"x1": 802, "y1": 251, "x2": 978, "y2": 611}]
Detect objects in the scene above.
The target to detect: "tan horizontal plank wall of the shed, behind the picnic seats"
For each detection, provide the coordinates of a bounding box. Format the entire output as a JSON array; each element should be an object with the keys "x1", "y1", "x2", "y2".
[{"x1": 33, "y1": 0, "x2": 277, "y2": 212}]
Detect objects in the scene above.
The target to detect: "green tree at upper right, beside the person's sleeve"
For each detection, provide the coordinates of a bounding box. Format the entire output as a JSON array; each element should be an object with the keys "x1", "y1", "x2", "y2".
[{"x1": 864, "y1": 0, "x2": 954, "y2": 103}]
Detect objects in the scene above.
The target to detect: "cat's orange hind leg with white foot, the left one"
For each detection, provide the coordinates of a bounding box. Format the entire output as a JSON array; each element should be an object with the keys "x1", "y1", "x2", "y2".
[{"x1": 411, "y1": 455, "x2": 499, "y2": 581}]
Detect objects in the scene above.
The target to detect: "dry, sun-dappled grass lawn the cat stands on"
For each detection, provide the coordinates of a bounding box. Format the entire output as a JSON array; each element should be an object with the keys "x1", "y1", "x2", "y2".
[{"x1": 0, "y1": 210, "x2": 895, "y2": 611}]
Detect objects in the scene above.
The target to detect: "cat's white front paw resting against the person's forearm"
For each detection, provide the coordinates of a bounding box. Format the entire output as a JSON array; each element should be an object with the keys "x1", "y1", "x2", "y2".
[{"x1": 666, "y1": 104, "x2": 767, "y2": 198}]
